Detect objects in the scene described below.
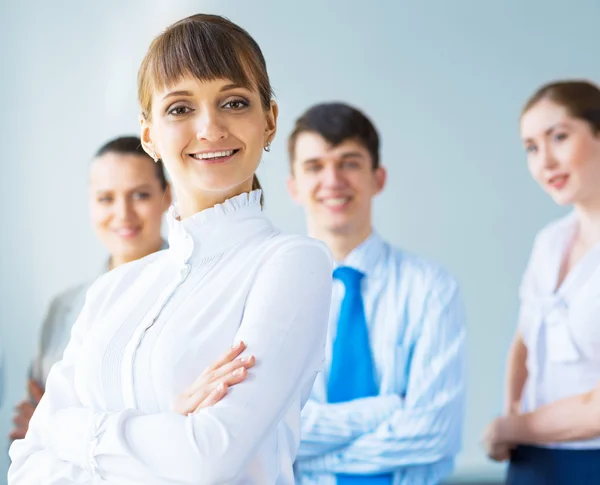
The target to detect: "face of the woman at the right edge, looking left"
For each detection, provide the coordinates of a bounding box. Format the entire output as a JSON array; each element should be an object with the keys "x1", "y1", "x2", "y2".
[{"x1": 521, "y1": 100, "x2": 600, "y2": 205}]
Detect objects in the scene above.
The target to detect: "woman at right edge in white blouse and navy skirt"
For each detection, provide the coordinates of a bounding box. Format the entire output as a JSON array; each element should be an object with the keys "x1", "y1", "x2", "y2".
[{"x1": 486, "y1": 81, "x2": 600, "y2": 485}]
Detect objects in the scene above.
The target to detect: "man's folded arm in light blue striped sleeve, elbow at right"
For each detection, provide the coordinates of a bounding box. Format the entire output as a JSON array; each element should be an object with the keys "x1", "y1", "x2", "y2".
[{"x1": 297, "y1": 287, "x2": 465, "y2": 474}]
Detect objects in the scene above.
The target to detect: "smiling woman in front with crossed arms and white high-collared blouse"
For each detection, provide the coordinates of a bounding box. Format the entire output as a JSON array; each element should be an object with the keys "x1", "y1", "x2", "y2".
[{"x1": 9, "y1": 15, "x2": 332, "y2": 485}]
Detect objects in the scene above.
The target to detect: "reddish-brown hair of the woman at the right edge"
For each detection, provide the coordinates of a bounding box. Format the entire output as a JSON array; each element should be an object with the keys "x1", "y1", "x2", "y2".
[{"x1": 522, "y1": 81, "x2": 600, "y2": 135}]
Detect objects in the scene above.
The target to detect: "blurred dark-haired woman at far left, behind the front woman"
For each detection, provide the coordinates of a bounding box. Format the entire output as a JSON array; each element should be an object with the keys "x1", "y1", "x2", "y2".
[{"x1": 9, "y1": 136, "x2": 171, "y2": 440}]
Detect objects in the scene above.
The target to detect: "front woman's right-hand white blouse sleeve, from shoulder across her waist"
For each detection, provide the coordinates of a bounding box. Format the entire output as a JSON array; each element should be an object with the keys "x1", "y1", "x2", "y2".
[{"x1": 11, "y1": 238, "x2": 332, "y2": 484}]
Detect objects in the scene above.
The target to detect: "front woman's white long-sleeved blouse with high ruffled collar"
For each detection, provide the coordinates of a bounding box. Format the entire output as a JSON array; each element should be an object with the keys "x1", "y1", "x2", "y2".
[{"x1": 8, "y1": 191, "x2": 333, "y2": 485}]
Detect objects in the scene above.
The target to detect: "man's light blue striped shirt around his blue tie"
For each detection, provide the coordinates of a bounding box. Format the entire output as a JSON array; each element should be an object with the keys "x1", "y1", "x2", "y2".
[{"x1": 295, "y1": 233, "x2": 466, "y2": 485}]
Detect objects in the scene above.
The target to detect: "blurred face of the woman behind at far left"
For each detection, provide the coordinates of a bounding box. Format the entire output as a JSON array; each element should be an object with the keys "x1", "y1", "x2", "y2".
[{"x1": 89, "y1": 153, "x2": 171, "y2": 262}]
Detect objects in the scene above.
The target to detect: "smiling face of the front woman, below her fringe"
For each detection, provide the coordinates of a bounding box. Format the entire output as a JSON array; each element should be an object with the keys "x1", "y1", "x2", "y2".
[{"x1": 142, "y1": 78, "x2": 277, "y2": 217}]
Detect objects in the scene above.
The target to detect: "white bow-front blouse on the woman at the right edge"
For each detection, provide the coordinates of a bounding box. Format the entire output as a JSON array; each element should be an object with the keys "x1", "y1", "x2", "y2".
[{"x1": 519, "y1": 213, "x2": 600, "y2": 448}]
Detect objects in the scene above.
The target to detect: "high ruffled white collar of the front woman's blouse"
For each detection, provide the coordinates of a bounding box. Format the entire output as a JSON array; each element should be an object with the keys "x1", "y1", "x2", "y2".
[{"x1": 167, "y1": 190, "x2": 270, "y2": 262}]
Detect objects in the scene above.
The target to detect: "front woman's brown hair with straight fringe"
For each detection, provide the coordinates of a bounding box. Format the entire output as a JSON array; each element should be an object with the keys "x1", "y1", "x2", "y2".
[{"x1": 138, "y1": 14, "x2": 273, "y2": 203}]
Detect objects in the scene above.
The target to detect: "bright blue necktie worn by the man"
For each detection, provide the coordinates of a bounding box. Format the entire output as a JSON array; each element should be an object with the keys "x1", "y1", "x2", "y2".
[{"x1": 327, "y1": 266, "x2": 393, "y2": 485}]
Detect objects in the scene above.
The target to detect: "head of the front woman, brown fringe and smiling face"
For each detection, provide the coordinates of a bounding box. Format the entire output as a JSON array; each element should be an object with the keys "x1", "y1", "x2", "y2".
[{"x1": 138, "y1": 16, "x2": 278, "y2": 214}]
